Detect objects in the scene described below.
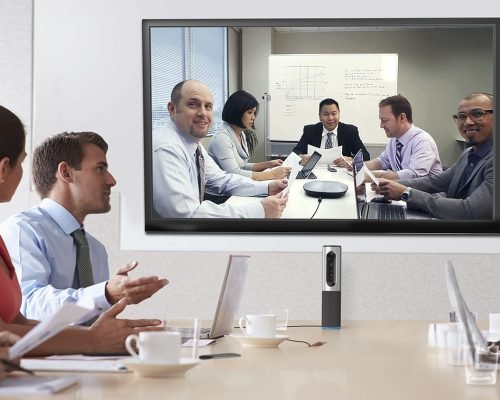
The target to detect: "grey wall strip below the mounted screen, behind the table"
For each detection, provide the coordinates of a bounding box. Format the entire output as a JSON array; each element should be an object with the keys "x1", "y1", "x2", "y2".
[{"x1": 86, "y1": 193, "x2": 500, "y2": 320}]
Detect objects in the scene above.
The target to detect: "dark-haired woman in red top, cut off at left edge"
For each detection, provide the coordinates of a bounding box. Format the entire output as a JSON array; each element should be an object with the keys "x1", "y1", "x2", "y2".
[{"x1": 0, "y1": 106, "x2": 161, "y2": 356}]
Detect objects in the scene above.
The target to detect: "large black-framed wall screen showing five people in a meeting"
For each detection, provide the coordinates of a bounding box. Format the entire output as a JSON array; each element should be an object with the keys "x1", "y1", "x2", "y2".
[{"x1": 143, "y1": 19, "x2": 500, "y2": 234}]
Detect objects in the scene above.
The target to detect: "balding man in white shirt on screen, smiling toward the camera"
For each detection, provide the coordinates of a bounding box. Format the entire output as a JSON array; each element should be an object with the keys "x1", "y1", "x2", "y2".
[{"x1": 153, "y1": 80, "x2": 288, "y2": 218}]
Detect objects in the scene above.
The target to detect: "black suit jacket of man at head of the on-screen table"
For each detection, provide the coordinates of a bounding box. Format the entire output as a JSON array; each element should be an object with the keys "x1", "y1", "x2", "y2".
[{"x1": 293, "y1": 122, "x2": 370, "y2": 161}]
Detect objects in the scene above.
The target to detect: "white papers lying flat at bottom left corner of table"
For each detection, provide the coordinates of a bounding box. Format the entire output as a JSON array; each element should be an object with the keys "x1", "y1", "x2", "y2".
[{"x1": 0, "y1": 376, "x2": 79, "y2": 396}]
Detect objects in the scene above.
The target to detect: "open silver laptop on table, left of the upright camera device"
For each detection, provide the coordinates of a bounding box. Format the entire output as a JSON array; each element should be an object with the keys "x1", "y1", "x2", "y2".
[{"x1": 167, "y1": 255, "x2": 250, "y2": 341}]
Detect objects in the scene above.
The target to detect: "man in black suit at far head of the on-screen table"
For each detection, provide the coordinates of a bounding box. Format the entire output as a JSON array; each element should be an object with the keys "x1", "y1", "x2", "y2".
[{"x1": 293, "y1": 99, "x2": 370, "y2": 163}]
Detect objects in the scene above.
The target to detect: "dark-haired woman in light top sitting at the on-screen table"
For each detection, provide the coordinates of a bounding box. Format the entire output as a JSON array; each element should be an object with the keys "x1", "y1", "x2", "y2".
[{"x1": 208, "y1": 90, "x2": 290, "y2": 181}]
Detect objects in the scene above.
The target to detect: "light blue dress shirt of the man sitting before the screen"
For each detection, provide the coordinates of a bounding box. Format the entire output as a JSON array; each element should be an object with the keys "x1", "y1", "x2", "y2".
[{"x1": 2, "y1": 218, "x2": 110, "y2": 322}]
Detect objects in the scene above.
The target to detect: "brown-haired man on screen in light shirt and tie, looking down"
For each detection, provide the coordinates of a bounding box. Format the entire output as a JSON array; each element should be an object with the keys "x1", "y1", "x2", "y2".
[{"x1": 365, "y1": 95, "x2": 443, "y2": 180}]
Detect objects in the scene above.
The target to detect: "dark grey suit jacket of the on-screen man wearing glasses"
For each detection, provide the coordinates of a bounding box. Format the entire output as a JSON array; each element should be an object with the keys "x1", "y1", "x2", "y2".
[{"x1": 398, "y1": 149, "x2": 494, "y2": 219}]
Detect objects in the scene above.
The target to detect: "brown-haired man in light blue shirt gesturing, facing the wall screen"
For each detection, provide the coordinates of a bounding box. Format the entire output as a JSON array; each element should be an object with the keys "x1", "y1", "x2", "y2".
[{"x1": 0, "y1": 132, "x2": 168, "y2": 322}]
